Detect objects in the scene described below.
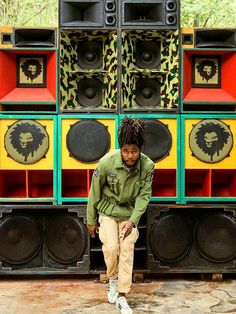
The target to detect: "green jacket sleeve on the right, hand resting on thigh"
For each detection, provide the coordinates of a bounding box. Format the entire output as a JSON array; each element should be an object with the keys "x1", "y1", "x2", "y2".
[{"x1": 129, "y1": 164, "x2": 154, "y2": 226}]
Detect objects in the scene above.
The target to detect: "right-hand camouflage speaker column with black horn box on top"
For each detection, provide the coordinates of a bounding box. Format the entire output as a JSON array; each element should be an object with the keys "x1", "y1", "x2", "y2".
[{"x1": 120, "y1": 0, "x2": 179, "y2": 113}]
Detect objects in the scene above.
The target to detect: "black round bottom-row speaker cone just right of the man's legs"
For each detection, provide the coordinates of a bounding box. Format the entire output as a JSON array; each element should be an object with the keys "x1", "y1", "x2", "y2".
[{"x1": 149, "y1": 214, "x2": 192, "y2": 262}]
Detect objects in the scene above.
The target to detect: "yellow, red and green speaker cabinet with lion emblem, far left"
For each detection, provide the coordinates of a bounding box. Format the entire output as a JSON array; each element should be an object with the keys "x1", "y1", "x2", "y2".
[{"x1": 0, "y1": 116, "x2": 57, "y2": 203}]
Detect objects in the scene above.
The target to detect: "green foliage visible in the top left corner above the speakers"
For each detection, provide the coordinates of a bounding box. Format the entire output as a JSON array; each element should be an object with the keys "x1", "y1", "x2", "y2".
[{"x1": 0, "y1": 0, "x2": 58, "y2": 27}]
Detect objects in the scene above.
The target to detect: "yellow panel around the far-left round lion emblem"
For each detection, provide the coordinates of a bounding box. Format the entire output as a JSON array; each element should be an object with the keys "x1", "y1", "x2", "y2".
[{"x1": 0, "y1": 119, "x2": 54, "y2": 170}]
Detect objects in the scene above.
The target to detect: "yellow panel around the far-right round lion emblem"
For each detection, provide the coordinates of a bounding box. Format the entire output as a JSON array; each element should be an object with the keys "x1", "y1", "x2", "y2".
[{"x1": 184, "y1": 118, "x2": 236, "y2": 169}]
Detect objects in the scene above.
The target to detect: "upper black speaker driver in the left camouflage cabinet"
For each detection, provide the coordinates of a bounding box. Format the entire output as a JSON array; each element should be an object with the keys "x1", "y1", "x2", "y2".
[{"x1": 78, "y1": 41, "x2": 103, "y2": 69}]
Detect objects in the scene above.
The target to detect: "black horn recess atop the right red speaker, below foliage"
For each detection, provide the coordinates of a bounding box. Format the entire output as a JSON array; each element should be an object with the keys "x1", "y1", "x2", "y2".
[{"x1": 194, "y1": 28, "x2": 236, "y2": 49}]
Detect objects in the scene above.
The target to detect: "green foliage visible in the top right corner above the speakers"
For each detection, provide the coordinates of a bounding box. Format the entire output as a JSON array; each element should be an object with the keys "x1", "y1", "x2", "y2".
[{"x1": 181, "y1": 0, "x2": 236, "y2": 28}]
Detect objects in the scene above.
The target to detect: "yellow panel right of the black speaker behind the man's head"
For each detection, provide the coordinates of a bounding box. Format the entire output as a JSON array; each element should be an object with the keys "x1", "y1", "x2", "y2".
[{"x1": 155, "y1": 119, "x2": 177, "y2": 169}]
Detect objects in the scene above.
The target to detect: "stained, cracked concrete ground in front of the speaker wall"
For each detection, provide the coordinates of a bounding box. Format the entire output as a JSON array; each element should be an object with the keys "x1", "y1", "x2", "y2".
[{"x1": 0, "y1": 275, "x2": 236, "y2": 314}]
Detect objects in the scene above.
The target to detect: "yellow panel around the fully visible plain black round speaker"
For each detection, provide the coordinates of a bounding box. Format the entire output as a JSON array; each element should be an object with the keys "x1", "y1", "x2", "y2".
[{"x1": 61, "y1": 118, "x2": 117, "y2": 169}]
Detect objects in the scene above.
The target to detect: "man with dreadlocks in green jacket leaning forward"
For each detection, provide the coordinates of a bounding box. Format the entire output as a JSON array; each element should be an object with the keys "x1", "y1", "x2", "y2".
[{"x1": 87, "y1": 117, "x2": 154, "y2": 314}]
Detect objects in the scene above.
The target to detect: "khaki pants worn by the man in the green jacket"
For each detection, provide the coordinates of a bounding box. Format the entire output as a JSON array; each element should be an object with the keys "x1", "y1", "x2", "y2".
[{"x1": 99, "y1": 215, "x2": 139, "y2": 293}]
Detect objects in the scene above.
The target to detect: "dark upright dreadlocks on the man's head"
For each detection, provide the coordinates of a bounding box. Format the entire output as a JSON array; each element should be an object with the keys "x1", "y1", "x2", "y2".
[{"x1": 118, "y1": 117, "x2": 146, "y2": 149}]
